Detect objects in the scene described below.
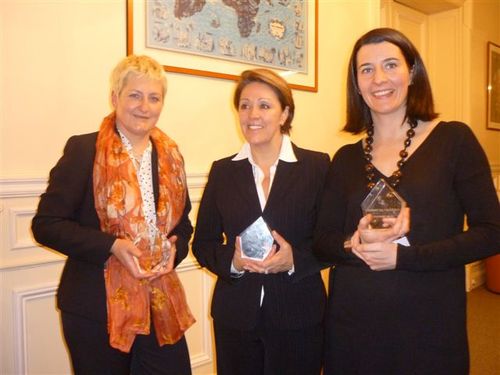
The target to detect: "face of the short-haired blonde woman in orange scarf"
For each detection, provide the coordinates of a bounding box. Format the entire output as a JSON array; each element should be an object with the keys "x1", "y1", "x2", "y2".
[{"x1": 111, "y1": 74, "x2": 163, "y2": 143}]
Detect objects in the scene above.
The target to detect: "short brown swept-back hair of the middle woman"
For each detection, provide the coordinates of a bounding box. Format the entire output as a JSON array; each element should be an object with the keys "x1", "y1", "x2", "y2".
[{"x1": 233, "y1": 69, "x2": 295, "y2": 134}]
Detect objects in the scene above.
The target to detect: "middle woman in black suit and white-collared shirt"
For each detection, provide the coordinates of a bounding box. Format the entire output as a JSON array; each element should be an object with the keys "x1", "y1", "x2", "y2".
[{"x1": 193, "y1": 69, "x2": 329, "y2": 375}]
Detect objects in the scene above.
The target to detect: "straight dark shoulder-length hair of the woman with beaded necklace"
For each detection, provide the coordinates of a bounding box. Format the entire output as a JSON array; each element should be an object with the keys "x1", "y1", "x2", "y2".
[{"x1": 343, "y1": 28, "x2": 438, "y2": 134}]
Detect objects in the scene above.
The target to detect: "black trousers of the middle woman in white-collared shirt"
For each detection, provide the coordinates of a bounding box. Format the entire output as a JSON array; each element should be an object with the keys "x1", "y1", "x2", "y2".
[{"x1": 214, "y1": 321, "x2": 323, "y2": 375}]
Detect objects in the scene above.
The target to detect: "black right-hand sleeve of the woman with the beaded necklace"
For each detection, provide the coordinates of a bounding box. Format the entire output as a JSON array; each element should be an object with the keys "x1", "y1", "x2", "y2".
[{"x1": 397, "y1": 125, "x2": 500, "y2": 271}]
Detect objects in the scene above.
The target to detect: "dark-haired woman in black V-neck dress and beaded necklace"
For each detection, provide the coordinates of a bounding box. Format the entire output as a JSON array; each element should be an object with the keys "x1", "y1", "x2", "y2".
[{"x1": 313, "y1": 28, "x2": 500, "y2": 375}]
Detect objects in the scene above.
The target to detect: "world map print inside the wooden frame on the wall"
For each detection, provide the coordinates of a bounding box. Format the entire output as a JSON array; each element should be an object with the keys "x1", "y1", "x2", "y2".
[{"x1": 146, "y1": 0, "x2": 308, "y2": 73}]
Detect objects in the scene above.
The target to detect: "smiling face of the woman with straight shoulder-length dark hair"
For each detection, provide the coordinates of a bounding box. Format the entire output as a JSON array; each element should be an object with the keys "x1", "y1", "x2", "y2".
[{"x1": 356, "y1": 42, "x2": 411, "y2": 120}]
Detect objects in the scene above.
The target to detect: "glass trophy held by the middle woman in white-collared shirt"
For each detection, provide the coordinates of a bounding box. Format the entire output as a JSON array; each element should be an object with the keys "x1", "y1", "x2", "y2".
[{"x1": 240, "y1": 216, "x2": 274, "y2": 260}]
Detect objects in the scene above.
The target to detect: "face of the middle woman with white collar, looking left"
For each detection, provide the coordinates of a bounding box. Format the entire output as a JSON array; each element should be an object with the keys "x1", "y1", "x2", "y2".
[{"x1": 238, "y1": 82, "x2": 288, "y2": 149}]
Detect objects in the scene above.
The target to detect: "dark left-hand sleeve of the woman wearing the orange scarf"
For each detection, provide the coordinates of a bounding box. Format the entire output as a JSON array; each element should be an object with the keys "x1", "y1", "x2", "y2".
[{"x1": 32, "y1": 133, "x2": 115, "y2": 266}]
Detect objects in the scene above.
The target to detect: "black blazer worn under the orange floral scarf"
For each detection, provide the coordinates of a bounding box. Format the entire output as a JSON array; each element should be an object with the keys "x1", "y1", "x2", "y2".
[{"x1": 31, "y1": 132, "x2": 193, "y2": 321}]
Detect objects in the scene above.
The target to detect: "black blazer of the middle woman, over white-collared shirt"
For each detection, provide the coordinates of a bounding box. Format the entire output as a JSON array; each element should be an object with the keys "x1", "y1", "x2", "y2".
[{"x1": 193, "y1": 145, "x2": 329, "y2": 330}]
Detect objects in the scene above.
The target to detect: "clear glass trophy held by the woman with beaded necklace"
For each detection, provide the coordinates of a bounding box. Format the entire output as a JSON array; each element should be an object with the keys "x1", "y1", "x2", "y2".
[{"x1": 361, "y1": 178, "x2": 406, "y2": 229}]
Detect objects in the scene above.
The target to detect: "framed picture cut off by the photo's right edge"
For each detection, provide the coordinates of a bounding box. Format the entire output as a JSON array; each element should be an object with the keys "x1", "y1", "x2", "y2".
[{"x1": 486, "y1": 42, "x2": 500, "y2": 130}]
